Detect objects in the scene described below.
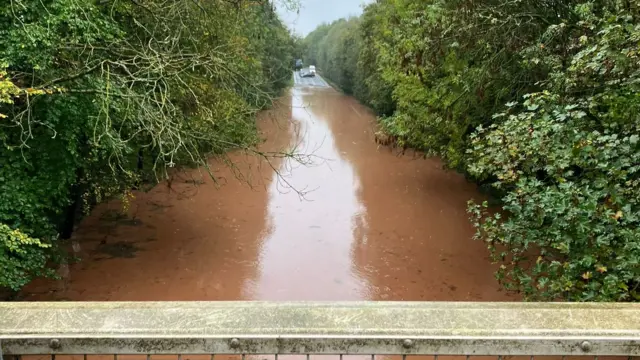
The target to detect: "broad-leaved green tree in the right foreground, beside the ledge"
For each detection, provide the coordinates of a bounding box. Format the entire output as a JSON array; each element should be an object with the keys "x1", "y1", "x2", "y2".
[{"x1": 470, "y1": 2, "x2": 640, "y2": 301}]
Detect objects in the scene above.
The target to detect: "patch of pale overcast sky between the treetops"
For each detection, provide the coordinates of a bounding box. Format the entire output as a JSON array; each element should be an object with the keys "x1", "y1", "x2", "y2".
[{"x1": 279, "y1": 0, "x2": 372, "y2": 36}]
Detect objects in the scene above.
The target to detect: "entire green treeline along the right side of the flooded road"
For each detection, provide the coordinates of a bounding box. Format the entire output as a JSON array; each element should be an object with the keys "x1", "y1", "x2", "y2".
[{"x1": 305, "y1": 0, "x2": 640, "y2": 301}]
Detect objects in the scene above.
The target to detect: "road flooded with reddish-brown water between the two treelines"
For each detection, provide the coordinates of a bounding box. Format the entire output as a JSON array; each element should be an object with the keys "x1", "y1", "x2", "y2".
[{"x1": 24, "y1": 72, "x2": 509, "y2": 301}]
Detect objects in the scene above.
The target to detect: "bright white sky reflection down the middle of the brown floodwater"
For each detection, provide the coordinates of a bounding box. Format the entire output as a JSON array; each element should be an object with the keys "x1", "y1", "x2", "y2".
[{"x1": 255, "y1": 89, "x2": 368, "y2": 300}]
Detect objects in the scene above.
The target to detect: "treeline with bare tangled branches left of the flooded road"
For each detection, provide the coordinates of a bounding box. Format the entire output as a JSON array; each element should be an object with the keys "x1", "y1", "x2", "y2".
[{"x1": 0, "y1": 0, "x2": 293, "y2": 289}]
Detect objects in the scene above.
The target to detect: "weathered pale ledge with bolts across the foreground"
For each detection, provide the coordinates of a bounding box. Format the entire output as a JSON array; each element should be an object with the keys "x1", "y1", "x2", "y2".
[{"x1": 0, "y1": 302, "x2": 640, "y2": 356}]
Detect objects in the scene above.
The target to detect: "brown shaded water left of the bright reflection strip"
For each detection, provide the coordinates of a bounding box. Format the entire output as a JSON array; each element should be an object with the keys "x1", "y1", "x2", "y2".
[{"x1": 22, "y1": 97, "x2": 291, "y2": 301}]
